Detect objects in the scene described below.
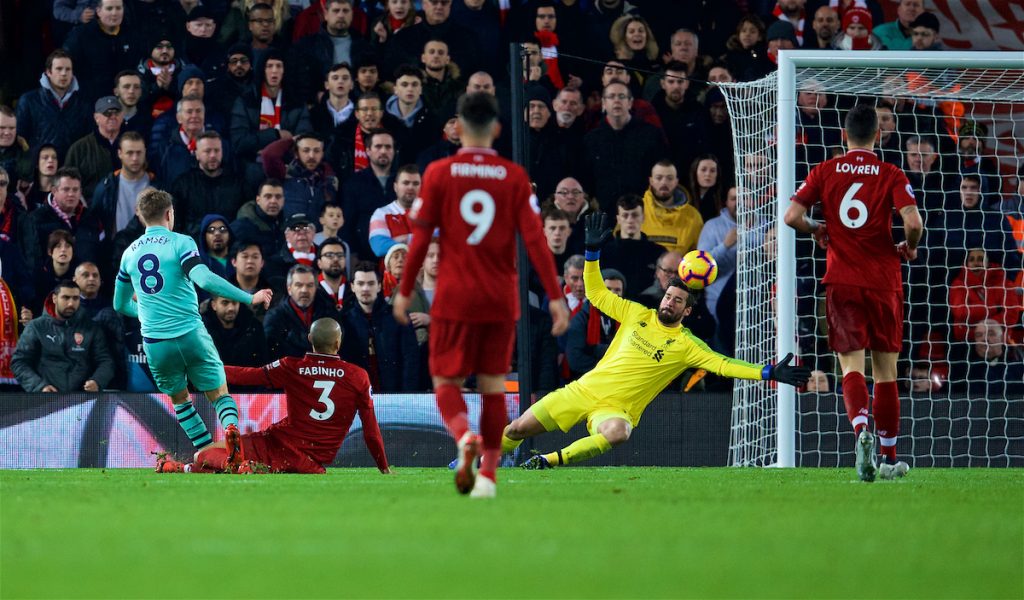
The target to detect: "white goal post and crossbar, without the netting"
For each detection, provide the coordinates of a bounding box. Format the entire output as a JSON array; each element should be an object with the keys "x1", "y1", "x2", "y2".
[{"x1": 773, "y1": 50, "x2": 1024, "y2": 467}]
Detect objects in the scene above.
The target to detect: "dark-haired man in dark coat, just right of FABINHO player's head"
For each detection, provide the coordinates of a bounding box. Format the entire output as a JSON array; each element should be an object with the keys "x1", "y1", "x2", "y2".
[{"x1": 341, "y1": 263, "x2": 421, "y2": 392}]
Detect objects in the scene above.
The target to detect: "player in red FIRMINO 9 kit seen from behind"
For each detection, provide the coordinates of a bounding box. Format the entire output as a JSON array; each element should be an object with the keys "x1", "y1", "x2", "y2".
[{"x1": 394, "y1": 92, "x2": 569, "y2": 498}]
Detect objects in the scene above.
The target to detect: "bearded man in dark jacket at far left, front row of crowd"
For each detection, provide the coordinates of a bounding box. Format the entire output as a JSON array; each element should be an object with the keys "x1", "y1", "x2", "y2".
[{"x1": 11, "y1": 281, "x2": 114, "y2": 392}]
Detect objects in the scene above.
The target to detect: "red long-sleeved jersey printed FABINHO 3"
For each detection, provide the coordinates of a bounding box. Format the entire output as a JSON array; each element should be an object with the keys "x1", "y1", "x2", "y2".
[{"x1": 224, "y1": 352, "x2": 388, "y2": 470}]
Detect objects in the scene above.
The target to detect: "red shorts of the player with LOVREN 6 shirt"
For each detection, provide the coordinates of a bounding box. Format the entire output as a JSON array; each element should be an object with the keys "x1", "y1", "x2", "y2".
[{"x1": 825, "y1": 285, "x2": 903, "y2": 352}]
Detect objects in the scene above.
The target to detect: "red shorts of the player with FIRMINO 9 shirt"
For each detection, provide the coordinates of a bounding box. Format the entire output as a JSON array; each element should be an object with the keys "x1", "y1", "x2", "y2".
[{"x1": 430, "y1": 318, "x2": 515, "y2": 378}]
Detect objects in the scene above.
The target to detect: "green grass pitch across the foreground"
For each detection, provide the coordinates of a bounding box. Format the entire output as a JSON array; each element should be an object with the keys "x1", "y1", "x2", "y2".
[{"x1": 0, "y1": 467, "x2": 1024, "y2": 599}]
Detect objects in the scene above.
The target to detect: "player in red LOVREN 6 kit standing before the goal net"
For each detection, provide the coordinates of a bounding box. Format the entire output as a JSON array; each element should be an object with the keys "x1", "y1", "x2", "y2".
[{"x1": 783, "y1": 104, "x2": 925, "y2": 481}]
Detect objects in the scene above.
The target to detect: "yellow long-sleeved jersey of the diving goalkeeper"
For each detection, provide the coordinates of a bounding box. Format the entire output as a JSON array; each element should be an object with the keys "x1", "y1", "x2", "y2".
[{"x1": 577, "y1": 260, "x2": 763, "y2": 426}]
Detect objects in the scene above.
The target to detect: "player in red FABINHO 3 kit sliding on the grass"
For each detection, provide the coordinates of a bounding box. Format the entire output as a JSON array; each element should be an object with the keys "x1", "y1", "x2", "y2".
[{"x1": 157, "y1": 318, "x2": 391, "y2": 474}]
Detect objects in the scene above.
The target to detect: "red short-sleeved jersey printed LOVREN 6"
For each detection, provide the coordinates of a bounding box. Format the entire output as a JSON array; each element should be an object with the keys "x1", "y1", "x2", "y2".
[{"x1": 793, "y1": 149, "x2": 916, "y2": 291}]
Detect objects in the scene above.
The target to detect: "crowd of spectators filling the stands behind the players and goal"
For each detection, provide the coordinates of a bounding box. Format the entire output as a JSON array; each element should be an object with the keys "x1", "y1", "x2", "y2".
[{"x1": 0, "y1": 0, "x2": 1024, "y2": 392}]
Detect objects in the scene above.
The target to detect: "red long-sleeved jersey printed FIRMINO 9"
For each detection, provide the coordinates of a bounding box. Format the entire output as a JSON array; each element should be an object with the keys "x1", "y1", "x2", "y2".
[{"x1": 401, "y1": 148, "x2": 562, "y2": 323}]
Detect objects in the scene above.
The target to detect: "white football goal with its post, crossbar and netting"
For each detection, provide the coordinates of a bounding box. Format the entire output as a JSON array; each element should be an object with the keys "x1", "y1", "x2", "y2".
[{"x1": 720, "y1": 50, "x2": 1024, "y2": 467}]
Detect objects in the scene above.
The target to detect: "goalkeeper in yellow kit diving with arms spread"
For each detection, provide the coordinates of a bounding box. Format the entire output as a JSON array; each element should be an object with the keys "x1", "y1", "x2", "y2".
[{"x1": 502, "y1": 214, "x2": 810, "y2": 469}]
